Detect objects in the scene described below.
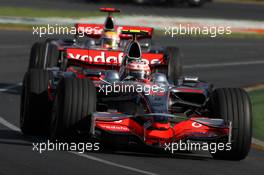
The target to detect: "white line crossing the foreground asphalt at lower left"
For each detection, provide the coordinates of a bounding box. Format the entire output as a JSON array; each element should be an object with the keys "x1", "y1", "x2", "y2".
[{"x1": 0, "y1": 116, "x2": 158, "y2": 175}]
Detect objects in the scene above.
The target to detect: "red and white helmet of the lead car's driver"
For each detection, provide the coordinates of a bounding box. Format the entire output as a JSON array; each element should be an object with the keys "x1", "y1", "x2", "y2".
[{"x1": 126, "y1": 60, "x2": 150, "y2": 80}]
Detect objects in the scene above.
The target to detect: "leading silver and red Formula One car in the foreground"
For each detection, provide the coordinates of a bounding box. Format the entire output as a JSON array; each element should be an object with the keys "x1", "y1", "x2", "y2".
[{"x1": 20, "y1": 30, "x2": 252, "y2": 160}]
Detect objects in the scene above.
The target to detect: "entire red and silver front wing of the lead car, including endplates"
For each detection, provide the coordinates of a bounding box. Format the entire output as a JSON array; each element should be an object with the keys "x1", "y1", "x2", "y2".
[{"x1": 90, "y1": 112, "x2": 232, "y2": 147}]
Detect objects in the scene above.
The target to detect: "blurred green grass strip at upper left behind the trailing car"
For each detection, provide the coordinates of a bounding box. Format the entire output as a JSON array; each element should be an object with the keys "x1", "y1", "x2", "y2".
[{"x1": 0, "y1": 7, "x2": 105, "y2": 18}]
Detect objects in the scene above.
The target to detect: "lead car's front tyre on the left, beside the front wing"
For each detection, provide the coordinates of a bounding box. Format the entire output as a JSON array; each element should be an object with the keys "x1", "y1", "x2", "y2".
[{"x1": 50, "y1": 78, "x2": 96, "y2": 139}]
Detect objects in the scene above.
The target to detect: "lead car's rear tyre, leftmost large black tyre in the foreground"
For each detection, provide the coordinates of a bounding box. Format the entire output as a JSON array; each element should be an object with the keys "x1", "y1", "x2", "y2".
[{"x1": 20, "y1": 69, "x2": 52, "y2": 135}]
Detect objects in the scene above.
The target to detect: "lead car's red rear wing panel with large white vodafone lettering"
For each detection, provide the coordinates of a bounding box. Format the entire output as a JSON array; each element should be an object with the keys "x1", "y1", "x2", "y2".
[{"x1": 67, "y1": 49, "x2": 163, "y2": 65}]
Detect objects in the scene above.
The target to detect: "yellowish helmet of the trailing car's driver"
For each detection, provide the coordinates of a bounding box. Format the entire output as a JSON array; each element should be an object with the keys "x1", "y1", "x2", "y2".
[{"x1": 101, "y1": 31, "x2": 120, "y2": 49}]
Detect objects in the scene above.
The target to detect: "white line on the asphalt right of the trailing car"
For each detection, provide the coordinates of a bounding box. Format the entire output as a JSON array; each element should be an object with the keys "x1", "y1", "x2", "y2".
[{"x1": 183, "y1": 60, "x2": 264, "y2": 69}]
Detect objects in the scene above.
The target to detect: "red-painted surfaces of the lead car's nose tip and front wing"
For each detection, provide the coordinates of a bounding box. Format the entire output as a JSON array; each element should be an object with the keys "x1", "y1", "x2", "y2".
[{"x1": 95, "y1": 114, "x2": 229, "y2": 146}]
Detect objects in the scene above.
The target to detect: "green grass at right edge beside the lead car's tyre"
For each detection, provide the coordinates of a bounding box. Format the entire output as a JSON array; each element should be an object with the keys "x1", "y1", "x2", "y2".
[{"x1": 250, "y1": 90, "x2": 264, "y2": 141}]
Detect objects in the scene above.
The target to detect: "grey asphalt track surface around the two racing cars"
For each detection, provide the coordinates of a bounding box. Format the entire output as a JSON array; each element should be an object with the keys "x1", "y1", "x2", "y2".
[{"x1": 0, "y1": 31, "x2": 264, "y2": 175}]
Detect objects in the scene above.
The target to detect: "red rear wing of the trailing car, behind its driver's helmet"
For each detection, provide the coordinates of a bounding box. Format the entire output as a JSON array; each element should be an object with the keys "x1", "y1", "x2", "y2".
[{"x1": 75, "y1": 23, "x2": 154, "y2": 39}]
